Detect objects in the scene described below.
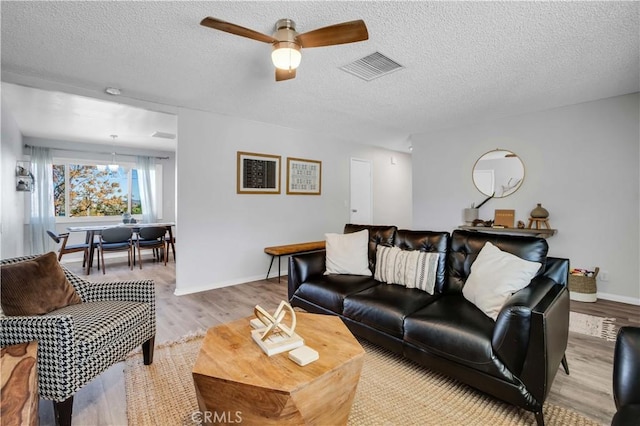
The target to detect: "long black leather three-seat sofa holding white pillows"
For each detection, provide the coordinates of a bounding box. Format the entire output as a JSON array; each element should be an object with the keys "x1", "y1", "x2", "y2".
[{"x1": 288, "y1": 224, "x2": 569, "y2": 425}]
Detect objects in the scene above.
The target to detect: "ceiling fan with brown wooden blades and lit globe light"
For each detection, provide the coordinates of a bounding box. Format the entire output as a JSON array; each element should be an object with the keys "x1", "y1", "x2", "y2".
[{"x1": 200, "y1": 16, "x2": 369, "y2": 81}]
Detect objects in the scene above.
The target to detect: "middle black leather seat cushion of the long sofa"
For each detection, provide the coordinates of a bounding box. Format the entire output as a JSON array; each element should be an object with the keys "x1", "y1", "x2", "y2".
[{"x1": 343, "y1": 284, "x2": 437, "y2": 339}]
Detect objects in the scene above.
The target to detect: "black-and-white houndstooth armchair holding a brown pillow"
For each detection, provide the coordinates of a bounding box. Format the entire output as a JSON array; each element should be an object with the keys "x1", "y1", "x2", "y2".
[{"x1": 0, "y1": 256, "x2": 156, "y2": 425}]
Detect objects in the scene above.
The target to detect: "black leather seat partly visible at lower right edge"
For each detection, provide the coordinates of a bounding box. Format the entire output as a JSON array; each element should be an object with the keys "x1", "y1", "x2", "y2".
[{"x1": 611, "y1": 326, "x2": 640, "y2": 426}]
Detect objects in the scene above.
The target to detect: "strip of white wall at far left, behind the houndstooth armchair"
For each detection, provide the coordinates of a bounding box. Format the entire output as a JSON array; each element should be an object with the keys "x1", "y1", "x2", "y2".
[{"x1": 0, "y1": 100, "x2": 25, "y2": 259}]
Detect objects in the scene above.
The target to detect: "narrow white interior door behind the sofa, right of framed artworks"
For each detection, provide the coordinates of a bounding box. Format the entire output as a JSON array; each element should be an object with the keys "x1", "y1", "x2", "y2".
[{"x1": 349, "y1": 158, "x2": 373, "y2": 225}]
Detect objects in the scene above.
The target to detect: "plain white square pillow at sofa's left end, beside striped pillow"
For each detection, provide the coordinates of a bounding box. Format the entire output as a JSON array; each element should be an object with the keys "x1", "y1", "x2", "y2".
[{"x1": 325, "y1": 229, "x2": 371, "y2": 276}]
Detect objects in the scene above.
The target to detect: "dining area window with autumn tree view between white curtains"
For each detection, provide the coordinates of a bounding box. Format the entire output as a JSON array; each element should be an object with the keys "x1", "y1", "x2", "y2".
[{"x1": 53, "y1": 159, "x2": 162, "y2": 218}]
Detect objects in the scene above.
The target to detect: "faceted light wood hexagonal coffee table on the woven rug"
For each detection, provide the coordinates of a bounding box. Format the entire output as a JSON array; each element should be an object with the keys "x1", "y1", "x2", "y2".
[{"x1": 193, "y1": 313, "x2": 364, "y2": 425}]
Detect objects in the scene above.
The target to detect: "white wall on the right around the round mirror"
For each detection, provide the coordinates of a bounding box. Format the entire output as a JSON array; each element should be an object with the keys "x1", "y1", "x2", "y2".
[{"x1": 412, "y1": 93, "x2": 640, "y2": 304}]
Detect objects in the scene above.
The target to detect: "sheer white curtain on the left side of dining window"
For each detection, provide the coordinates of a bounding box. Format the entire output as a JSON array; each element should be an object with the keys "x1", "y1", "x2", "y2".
[{"x1": 30, "y1": 146, "x2": 56, "y2": 254}]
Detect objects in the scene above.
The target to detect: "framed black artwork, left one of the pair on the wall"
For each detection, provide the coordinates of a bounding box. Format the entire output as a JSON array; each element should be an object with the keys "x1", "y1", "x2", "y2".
[{"x1": 236, "y1": 151, "x2": 281, "y2": 194}]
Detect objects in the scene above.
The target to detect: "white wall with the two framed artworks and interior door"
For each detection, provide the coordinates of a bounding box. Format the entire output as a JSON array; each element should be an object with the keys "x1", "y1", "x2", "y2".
[{"x1": 176, "y1": 109, "x2": 411, "y2": 294}]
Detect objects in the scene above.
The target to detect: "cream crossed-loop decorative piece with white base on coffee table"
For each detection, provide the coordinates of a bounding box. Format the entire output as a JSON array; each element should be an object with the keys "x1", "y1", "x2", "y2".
[{"x1": 251, "y1": 301, "x2": 304, "y2": 356}]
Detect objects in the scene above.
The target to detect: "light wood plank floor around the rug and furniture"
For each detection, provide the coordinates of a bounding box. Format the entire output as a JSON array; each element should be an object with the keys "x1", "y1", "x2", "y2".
[{"x1": 40, "y1": 256, "x2": 640, "y2": 425}]
